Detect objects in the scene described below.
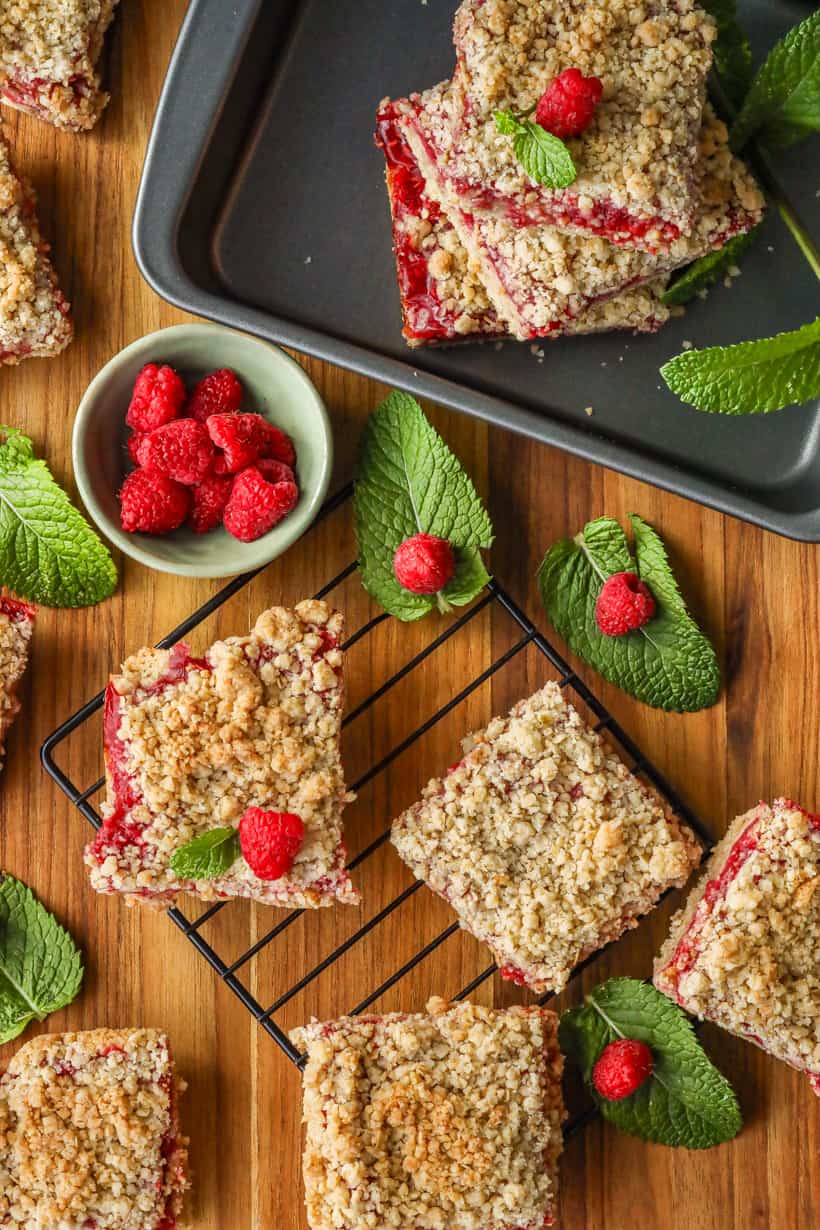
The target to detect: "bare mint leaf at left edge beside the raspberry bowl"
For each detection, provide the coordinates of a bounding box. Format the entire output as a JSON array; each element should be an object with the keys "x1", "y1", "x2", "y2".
[{"x1": 0, "y1": 427, "x2": 117, "y2": 606}]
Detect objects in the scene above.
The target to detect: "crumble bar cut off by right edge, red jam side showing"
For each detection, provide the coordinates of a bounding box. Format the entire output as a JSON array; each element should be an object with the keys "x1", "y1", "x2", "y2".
[{"x1": 654, "y1": 798, "x2": 820, "y2": 1095}]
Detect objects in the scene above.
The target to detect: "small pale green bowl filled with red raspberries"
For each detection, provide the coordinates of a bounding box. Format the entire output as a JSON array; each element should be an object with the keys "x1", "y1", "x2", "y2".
[{"x1": 74, "y1": 323, "x2": 332, "y2": 577}]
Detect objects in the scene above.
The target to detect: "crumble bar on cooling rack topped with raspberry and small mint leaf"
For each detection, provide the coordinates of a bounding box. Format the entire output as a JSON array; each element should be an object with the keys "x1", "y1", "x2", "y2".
[{"x1": 86, "y1": 599, "x2": 359, "y2": 908}]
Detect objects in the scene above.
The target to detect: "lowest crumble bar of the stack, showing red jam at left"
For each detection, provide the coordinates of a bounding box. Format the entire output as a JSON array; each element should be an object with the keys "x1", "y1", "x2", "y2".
[{"x1": 376, "y1": 100, "x2": 669, "y2": 347}]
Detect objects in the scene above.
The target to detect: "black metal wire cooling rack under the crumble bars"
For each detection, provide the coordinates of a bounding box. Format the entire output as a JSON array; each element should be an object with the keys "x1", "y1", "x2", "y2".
[{"x1": 41, "y1": 487, "x2": 713, "y2": 1111}]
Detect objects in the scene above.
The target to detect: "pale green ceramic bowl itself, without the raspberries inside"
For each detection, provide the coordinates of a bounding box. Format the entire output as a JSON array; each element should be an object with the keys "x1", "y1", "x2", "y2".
[{"x1": 73, "y1": 323, "x2": 333, "y2": 577}]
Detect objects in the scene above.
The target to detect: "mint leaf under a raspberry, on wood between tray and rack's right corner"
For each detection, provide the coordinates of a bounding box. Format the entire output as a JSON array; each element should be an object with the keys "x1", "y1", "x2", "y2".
[{"x1": 538, "y1": 513, "x2": 720, "y2": 712}]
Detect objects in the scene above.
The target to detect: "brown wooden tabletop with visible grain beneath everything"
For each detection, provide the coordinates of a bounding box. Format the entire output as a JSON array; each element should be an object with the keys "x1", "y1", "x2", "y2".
[{"x1": 0, "y1": 0, "x2": 820, "y2": 1230}]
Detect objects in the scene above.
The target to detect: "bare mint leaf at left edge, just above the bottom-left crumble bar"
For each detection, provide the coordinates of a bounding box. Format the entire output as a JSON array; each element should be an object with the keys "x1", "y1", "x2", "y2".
[{"x1": 0, "y1": 876, "x2": 82, "y2": 1043}]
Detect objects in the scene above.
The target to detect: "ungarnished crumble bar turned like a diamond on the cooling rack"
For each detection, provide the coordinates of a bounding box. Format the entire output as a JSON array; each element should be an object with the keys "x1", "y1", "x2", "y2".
[{"x1": 392, "y1": 683, "x2": 701, "y2": 993}]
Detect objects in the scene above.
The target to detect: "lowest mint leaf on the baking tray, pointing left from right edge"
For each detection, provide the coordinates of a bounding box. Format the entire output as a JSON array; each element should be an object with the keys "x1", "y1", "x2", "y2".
[{"x1": 660, "y1": 316, "x2": 820, "y2": 415}]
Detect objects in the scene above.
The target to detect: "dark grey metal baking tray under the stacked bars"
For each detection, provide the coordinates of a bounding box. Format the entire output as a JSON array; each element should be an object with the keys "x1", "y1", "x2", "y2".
[{"x1": 133, "y1": 0, "x2": 820, "y2": 542}]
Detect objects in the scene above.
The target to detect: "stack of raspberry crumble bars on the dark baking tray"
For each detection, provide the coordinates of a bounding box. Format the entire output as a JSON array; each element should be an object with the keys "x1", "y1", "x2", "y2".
[{"x1": 376, "y1": 0, "x2": 763, "y2": 346}]
